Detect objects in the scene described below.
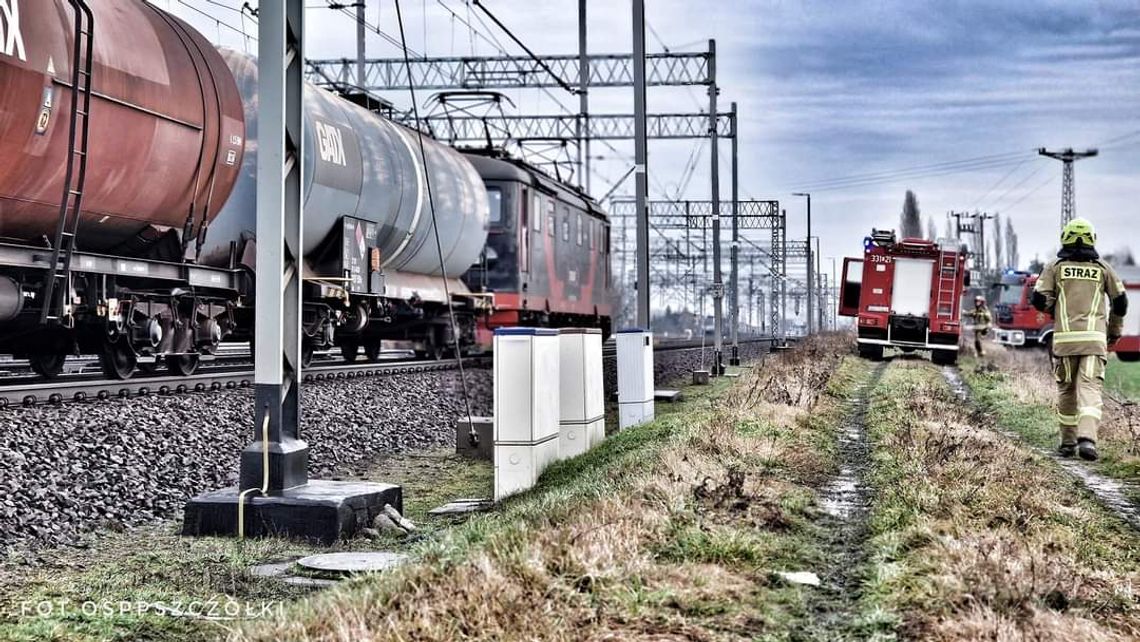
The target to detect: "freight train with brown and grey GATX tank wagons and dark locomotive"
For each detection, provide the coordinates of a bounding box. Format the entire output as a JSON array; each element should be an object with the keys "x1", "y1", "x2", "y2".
[{"x1": 0, "y1": 0, "x2": 610, "y2": 379}]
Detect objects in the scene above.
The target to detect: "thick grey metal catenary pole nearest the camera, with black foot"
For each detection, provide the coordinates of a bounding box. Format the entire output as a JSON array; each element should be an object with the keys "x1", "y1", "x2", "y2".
[{"x1": 239, "y1": 0, "x2": 309, "y2": 494}]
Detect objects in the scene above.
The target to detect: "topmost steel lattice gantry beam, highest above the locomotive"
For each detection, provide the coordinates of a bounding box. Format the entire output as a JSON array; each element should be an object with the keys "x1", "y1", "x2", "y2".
[{"x1": 307, "y1": 51, "x2": 713, "y2": 91}]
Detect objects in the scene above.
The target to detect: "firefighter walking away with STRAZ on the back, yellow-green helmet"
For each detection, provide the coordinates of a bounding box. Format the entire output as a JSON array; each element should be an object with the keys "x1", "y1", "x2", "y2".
[{"x1": 1033, "y1": 219, "x2": 1129, "y2": 461}]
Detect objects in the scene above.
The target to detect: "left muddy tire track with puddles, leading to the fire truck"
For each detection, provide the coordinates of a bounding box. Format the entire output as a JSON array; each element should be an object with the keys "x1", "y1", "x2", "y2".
[{"x1": 791, "y1": 361, "x2": 889, "y2": 642}]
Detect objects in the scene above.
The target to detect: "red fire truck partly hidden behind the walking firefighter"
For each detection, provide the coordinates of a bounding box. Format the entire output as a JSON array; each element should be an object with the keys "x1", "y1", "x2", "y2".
[{"x1": 993, "y1": 267, "x2": 1140, "y2": 361}]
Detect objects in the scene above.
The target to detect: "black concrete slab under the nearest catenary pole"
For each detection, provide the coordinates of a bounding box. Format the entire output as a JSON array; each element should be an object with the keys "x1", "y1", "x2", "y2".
[{"x1": 182, "y1": 480, "x2": 404, "y2": 545}]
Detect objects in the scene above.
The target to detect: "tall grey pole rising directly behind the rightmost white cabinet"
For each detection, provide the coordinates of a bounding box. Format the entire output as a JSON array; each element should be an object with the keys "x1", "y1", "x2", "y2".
[{"x1": 633, "y1": 0, "x2": 652, "y2": 331}]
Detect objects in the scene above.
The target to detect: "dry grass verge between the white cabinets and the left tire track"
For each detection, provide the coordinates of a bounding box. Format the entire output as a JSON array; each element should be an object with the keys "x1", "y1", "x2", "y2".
[{"x1": 233, "y1": 340, "x2": 861, "y2": 641}]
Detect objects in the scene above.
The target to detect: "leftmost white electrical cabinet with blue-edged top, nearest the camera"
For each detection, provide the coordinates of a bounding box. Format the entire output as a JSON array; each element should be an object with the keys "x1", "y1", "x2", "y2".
[{"x1": 494, "y1": 327, "x2": 561, "y2": 501}]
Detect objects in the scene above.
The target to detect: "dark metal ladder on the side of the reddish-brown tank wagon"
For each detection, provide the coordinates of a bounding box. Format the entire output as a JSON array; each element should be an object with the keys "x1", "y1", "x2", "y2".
[{"x1": 40, "y1": 0, "x2": 95, "y2": 324}]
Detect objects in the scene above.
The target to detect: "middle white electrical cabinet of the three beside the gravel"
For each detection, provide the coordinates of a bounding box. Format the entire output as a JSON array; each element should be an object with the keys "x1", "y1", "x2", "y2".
[{"x1": 559, "y1": 327, "x2": 605, "y2": 460}]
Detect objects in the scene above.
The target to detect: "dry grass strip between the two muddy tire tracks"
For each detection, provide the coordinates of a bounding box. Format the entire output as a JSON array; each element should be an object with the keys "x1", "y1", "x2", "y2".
[{"x1": 869, "y1": 364, "x2": 1140, "y2": 641}]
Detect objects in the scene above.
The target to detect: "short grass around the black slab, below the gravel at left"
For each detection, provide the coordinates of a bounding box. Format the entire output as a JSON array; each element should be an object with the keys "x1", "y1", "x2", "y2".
[{"x1": 0, "y1": 452, "x2": 491, "y2": 642}]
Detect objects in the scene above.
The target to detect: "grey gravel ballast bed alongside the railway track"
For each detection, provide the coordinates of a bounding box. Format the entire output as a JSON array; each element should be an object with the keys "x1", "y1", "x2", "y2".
[{"x1": 0, "y1": 343, "x2": 766, "y2": 551}]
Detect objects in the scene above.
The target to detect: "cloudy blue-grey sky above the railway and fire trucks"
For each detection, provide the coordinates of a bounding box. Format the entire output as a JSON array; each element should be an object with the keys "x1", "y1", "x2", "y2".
[{"x1": 165, "y1": 0, "x2": 1140, "y2": 286}]
